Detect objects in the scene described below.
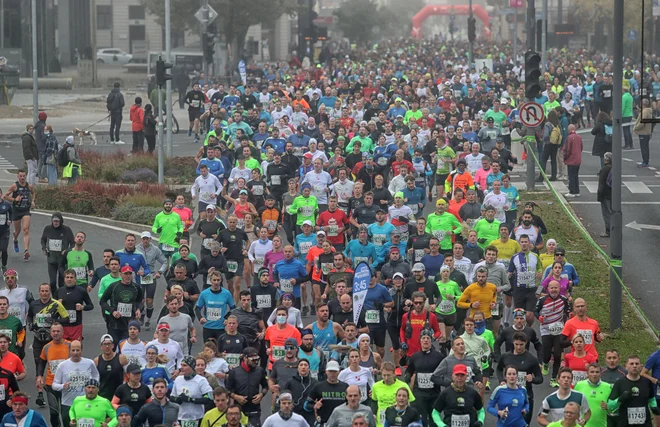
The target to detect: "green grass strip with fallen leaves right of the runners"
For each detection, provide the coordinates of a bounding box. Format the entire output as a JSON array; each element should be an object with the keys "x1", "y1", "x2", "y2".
[{"x1": 520, "y1": 192, "x2": 658, "y2": 362}]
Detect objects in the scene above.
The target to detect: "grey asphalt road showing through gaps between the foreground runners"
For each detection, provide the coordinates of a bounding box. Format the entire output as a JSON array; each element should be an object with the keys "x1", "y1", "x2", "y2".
[{"x1": 8, "y1": 212, "x2": 554, "y2": 427}]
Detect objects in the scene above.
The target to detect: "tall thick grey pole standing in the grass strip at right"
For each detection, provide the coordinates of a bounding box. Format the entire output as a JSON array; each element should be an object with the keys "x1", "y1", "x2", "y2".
[{"x1": 610, "y1": 0, "x2": 624, "y2": 332}]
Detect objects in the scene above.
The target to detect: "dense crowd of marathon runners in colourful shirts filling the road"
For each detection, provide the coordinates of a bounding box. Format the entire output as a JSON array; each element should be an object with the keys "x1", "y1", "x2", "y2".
[{"x1": 0, "y1": 36, "x2": 660, "y2": 427}]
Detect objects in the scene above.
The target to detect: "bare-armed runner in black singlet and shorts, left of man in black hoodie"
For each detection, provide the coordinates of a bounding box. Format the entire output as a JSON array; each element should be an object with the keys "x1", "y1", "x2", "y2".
[{"x1": 4, "y1": 169, "x2": 37, "y2": 261}]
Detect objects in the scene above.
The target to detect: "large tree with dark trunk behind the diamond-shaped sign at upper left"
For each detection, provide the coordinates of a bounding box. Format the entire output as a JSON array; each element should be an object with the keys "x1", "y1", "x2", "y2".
[{"x1": 143, "y1": 0, "x2": 298, "y2": 77}]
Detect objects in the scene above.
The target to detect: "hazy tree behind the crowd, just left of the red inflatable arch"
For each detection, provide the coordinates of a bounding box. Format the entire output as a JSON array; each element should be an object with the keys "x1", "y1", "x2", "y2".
[{"x1": 335, "y1": 0, "x2": 383, "y2": 44}]
